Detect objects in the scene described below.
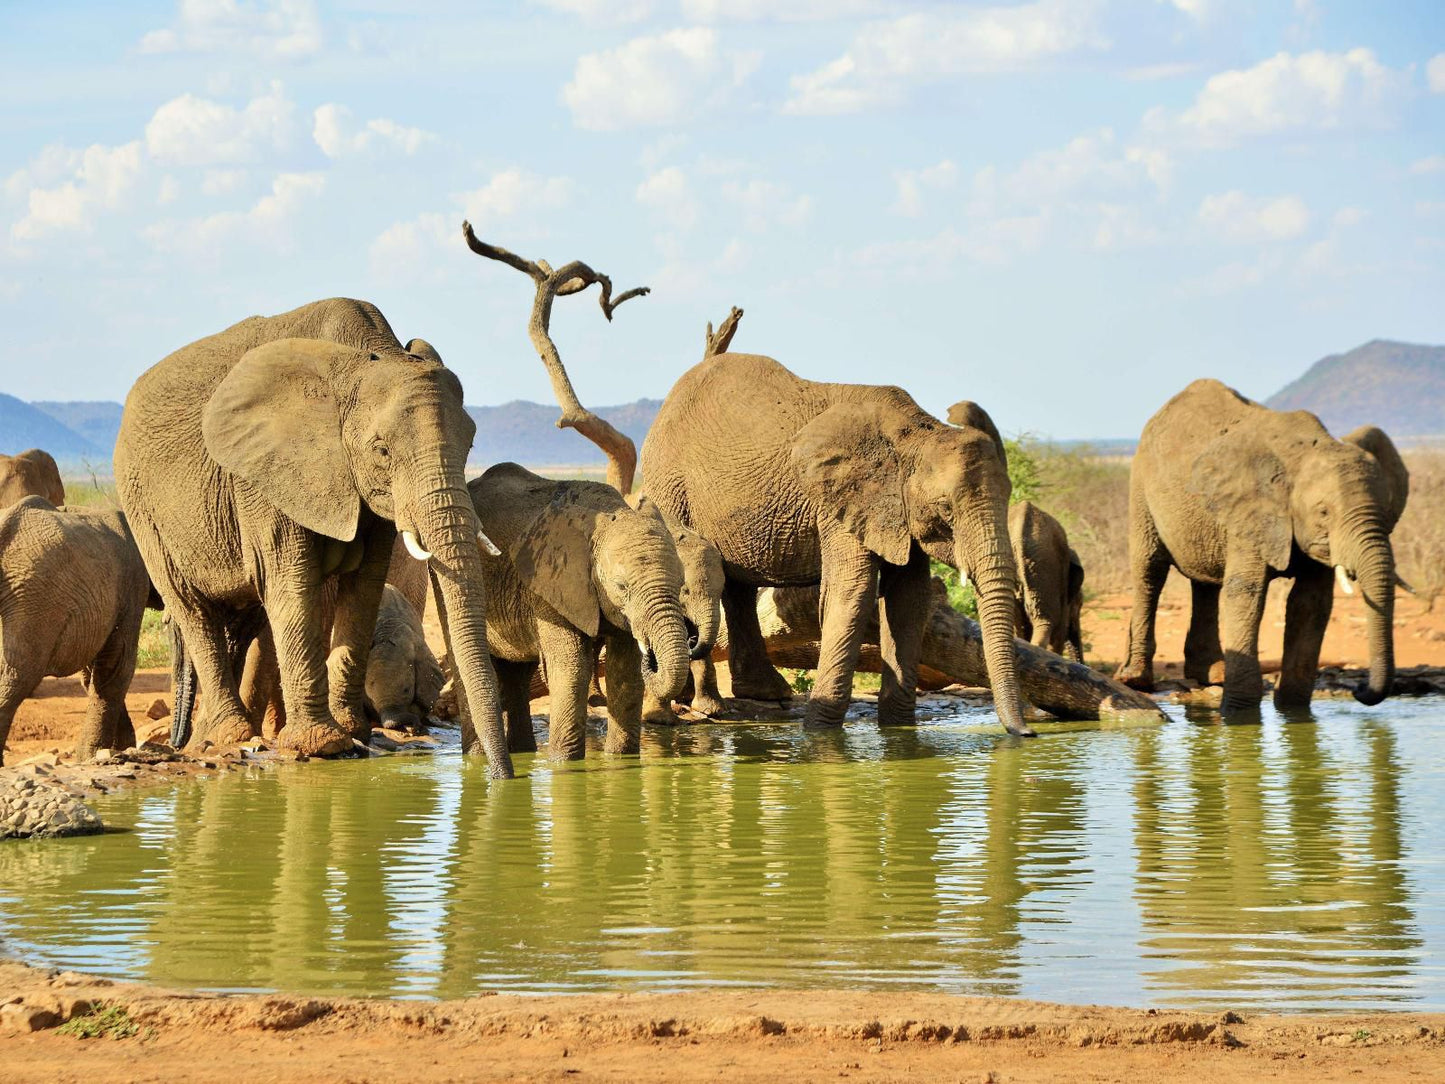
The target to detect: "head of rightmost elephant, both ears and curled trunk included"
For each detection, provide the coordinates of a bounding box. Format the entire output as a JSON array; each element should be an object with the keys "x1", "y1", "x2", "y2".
[{"x1": 1192, "y1": 423, "x2": 1410, "y2": 704}]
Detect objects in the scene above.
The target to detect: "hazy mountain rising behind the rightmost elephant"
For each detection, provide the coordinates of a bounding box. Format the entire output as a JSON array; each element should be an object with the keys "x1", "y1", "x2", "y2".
[{"x1": 1264, "y1": 338, "x2": 1445, "y2": 441}]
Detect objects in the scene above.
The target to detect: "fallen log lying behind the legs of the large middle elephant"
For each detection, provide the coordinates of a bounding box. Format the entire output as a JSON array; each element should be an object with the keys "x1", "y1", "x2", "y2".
[{"x1": 751, "y1": 578, "x2": 1165, "y2": 721}]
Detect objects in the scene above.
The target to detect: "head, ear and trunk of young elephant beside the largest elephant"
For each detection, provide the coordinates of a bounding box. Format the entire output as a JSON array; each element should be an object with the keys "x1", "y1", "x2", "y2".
[{"x1": 512, "y1": 483, "x2": 689, "y2": 700}]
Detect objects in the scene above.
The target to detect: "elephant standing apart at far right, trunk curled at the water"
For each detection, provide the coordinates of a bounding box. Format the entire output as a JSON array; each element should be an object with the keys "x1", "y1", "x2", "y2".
[{"x1": 1116, "y1": 380, "x2": 1410, "y2": 713}]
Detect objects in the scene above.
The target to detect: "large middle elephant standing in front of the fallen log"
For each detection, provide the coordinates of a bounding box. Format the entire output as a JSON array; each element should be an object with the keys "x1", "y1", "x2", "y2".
[{"x1": 642, "y1": 353, "x2": 1033, "y2": 734}]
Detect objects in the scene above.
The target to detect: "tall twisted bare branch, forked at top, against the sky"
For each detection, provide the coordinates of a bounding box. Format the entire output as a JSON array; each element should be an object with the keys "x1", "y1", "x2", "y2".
[{"x1": 461, "y1": 223, "x2": 650, "y2": 496}]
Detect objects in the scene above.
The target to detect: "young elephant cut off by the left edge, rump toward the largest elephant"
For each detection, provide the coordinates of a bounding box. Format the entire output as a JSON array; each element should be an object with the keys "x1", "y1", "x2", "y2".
[{"x1": 0, "y1": 496, "x2": 160, "y2": 765}]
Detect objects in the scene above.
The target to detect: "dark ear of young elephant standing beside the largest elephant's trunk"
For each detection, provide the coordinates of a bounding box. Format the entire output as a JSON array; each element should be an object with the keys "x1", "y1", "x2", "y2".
[{"x1": 512, "y1": 493, "x2": 601, "y2": 636}]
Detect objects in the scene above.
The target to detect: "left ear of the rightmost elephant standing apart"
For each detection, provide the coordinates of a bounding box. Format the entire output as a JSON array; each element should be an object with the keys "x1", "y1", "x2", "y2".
[{"x1": 1189, "y1": 429, "x2": 1295, "y2": 571}]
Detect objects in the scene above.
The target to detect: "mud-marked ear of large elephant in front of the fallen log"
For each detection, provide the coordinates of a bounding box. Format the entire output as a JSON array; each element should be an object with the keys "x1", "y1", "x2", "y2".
[{"x1": 792, "y1": 403, "x2": 913, "y2": 565}]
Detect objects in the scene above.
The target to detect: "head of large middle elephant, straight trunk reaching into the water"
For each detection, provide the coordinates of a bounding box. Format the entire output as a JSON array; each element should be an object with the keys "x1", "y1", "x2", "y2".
[{"x1": 792, "y1": 390, "x2": 1033, "y2": 734}]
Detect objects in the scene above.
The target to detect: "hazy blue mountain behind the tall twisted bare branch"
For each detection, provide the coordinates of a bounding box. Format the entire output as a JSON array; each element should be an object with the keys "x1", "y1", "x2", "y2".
[{"x1": 467, "y1": 399, "x2": 662, "y2": 467}]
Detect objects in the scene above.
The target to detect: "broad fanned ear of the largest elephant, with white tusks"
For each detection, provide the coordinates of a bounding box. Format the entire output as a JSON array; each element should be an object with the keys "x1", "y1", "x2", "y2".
[{"x1": 201, "y1": 338, "x2": 361, "y2": 542}]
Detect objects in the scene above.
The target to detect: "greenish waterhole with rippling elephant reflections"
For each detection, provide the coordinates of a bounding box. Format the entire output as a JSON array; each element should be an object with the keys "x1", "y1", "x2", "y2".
[{"x1": 0, "y1": 700, "x2": 1445, "y2": 1010}]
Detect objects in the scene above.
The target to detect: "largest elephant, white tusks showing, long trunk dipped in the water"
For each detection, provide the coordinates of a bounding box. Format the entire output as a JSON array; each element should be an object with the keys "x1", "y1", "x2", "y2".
[{"x1": 116, "y1": 298, "x2": 513, "y2": 778}]
